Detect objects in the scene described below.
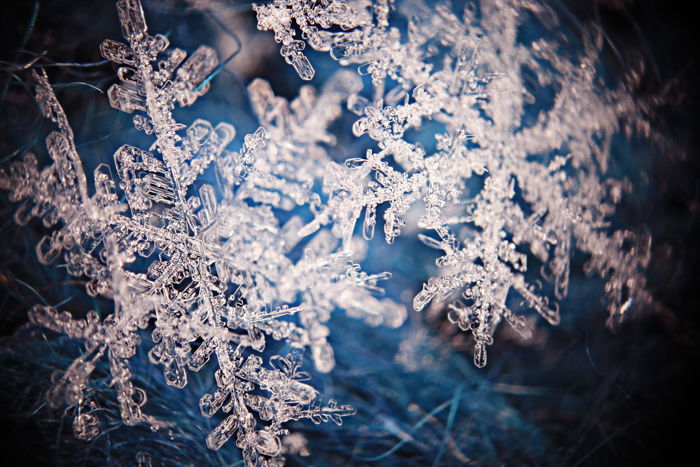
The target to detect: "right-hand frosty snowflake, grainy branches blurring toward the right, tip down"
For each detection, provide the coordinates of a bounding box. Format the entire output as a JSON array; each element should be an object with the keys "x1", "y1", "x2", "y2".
[{"x1": 254, "y1": 0, "x2": 651, "y2": 367}]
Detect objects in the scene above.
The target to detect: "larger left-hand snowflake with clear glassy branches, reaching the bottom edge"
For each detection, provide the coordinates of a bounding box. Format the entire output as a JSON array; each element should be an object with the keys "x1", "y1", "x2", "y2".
[{"x1": 0, "y1": 0, "x2": 405, "y2": 465}]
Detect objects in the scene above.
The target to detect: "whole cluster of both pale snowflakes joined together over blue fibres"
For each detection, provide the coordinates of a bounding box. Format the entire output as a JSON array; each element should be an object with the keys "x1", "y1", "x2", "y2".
[{"x1": 0, "y1": 0, "x2": 650, "y2": 465}]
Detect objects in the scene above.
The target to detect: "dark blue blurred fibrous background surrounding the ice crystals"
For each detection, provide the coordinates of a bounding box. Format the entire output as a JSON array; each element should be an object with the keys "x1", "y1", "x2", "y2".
[{"x1": 0, "y1": 0, "x2": 700, "y2": 466}]
